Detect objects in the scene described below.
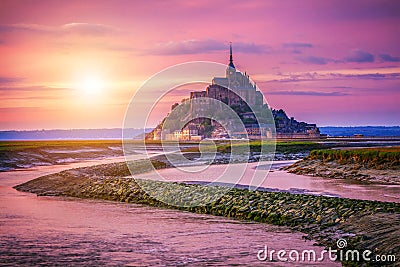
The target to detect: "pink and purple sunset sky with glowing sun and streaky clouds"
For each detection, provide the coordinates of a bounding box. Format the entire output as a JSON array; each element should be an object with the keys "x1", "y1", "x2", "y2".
[{"x1": 0, "y1": 0, "x2": 400, "y2": 130}]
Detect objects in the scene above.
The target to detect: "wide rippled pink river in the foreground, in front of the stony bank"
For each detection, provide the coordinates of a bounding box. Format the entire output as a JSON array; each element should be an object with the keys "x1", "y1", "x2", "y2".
[{"x1": 0, "y1": 158, "x2": 340, "y2": 266}]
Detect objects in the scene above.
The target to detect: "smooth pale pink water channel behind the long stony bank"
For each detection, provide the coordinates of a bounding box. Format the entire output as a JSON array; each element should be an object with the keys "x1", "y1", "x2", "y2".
[{"x1": 135, "y1": 161, "x2": 400, "y2": 203}]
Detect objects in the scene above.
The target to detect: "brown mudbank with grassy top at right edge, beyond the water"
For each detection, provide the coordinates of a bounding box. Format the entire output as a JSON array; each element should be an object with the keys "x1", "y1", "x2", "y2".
[{"x1": 286, "y1": 147, "x2": 400, "y2": 185}]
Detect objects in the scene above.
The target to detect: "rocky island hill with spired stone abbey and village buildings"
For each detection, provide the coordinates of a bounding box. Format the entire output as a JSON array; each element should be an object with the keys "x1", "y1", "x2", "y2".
[{"x1": 146, "y1": 45, "x2": 321, "y2": 141}]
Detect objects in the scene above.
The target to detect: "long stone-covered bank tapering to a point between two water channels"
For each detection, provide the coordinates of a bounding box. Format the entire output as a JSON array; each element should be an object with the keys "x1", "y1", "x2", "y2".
[{"x1": 15, "y1": 161, "x2": 400, "y2": 266}]
